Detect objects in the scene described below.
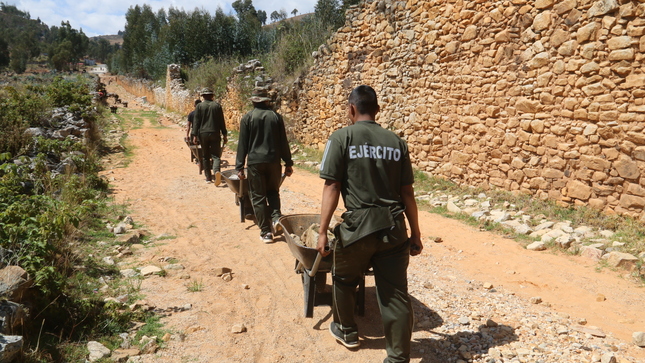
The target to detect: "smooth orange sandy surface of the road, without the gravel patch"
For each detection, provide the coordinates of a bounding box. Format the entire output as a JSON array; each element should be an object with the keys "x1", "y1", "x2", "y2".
[{"x1": 104, "y1": 84, "x2": 645, "y2": 362}]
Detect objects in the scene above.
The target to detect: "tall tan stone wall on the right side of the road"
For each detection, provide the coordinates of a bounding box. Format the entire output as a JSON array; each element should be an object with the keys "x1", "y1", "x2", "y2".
[{"x1": 282, "y1": 0, "x2": 645, "y2": 219}]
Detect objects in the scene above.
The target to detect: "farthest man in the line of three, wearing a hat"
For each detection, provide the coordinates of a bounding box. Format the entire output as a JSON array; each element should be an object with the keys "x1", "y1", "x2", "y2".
[{"x1": 191, "y1": 88, "x2": 228, "y2": 186}]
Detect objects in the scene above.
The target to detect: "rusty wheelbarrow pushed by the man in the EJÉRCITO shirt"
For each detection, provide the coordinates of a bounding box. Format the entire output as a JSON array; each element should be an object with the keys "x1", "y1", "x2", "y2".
[{"x1": 278, "y1": 214, "x2": 365, "y2": 318}]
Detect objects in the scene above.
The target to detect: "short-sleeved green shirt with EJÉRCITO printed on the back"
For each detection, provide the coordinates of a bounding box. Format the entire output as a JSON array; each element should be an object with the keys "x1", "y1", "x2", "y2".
[{"x1": 320, "y1": 121, "x2": 414, "y2": 213}]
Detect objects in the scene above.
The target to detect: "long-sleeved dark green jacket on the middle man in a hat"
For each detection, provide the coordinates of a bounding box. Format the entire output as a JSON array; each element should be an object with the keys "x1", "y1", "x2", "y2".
[{"x1": 235, "y1": 106, "x2": 293, "y2": 171}]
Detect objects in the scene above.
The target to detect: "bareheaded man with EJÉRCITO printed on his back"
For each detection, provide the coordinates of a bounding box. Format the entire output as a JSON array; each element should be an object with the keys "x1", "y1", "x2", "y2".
[{"x1": 317, "y1": 86, "x2": 423, "y2": 363}]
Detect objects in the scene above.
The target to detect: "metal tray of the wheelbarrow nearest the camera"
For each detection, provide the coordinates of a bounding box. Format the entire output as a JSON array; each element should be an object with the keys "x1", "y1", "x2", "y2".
[{"x1": 279, "y1": 214, "x2": 333, "y2": 271}]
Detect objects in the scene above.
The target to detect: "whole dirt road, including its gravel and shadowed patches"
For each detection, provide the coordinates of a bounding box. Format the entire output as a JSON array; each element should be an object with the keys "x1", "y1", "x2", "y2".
[{"x1": 103, "y1": 86, "x2": 645, "y2": 363}]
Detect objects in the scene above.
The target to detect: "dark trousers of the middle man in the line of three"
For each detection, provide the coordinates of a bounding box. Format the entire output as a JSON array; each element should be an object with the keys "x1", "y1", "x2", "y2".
[{"x1": 246, "y1": 163, "x2": 282, "y2": 234}]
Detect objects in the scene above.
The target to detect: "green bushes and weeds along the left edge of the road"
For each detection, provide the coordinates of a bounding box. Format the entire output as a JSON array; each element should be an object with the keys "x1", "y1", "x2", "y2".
[{"x1": 0, "y1": 73, "x2": 164, "y2": 362}]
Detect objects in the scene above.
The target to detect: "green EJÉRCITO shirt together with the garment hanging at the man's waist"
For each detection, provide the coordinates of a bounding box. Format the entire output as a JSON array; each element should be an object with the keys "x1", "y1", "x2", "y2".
[{"x1": 320, "y1": 121, "x2": 414, "y2": 246}]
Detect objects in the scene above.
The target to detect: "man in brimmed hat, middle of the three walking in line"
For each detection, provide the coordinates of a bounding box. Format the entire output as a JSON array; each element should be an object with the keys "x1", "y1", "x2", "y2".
[{"x1": 235, "y1": 88, "x2": 293, "y2": 243}]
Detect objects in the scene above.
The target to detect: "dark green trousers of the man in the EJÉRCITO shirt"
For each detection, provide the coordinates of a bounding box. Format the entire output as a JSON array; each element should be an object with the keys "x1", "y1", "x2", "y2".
[{"x1": 332, "y1": 227, "x2": 414, "y2": 363}]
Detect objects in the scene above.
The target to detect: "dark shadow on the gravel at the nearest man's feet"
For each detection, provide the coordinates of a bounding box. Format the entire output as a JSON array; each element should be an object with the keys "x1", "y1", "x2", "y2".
[{"x1": 314, "y1": 286, "x2": 518, "y2": 363}]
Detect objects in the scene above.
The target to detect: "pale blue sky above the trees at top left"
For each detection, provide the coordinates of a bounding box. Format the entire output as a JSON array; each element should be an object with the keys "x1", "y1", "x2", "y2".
[{"x1": 3, "y1": 0, "x2": 316, "y2": 37}]
